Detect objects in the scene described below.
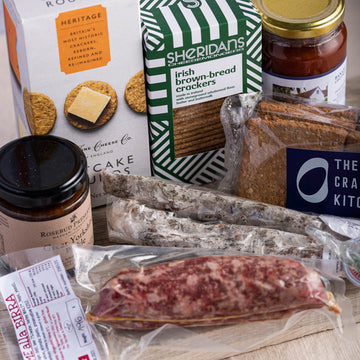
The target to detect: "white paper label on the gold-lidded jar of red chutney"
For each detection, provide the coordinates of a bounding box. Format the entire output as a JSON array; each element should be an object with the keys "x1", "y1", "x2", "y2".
[{"x1": 263, "y1": 58, "x2": 346, "y2": 105}]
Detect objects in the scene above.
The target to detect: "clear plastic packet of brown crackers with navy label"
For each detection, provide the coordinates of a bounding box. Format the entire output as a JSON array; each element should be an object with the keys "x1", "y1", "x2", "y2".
[{"x1": 220, "y1": 95, "x2": 360, "y2": 217}]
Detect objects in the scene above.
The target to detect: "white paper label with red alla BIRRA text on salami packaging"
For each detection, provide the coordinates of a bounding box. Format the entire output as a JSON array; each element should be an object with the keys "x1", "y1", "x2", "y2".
[{"x1": 0, "y1": 256, "x2": 100, "y2": 360}]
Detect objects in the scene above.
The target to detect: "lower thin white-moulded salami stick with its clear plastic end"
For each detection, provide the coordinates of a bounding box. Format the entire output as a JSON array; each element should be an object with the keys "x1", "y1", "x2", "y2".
[{"x1": 107, "y1": 196, "x2": 360, "y2": 286}]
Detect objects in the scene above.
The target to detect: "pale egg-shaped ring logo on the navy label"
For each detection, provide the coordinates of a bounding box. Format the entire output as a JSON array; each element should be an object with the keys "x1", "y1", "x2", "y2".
[{"x1": 296, "y1": 158, "x2": 329, "y2": 204}]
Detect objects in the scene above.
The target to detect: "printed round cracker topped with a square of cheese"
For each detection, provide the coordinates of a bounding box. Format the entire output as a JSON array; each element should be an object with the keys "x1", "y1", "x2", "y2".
[{"x1": 64, "y1": 80, "x2": 118, "y2": 130}]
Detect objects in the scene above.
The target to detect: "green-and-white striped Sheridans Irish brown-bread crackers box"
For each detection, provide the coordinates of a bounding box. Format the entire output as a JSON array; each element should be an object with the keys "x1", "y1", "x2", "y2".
[{"x1": 140, "y1": 0, "x2": 261, "y2": 183}]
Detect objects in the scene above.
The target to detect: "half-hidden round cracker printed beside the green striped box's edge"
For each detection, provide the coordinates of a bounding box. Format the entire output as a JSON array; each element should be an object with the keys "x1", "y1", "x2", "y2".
[{"x1": 124, "y1": 70, "x2": 146, "y2": 113}]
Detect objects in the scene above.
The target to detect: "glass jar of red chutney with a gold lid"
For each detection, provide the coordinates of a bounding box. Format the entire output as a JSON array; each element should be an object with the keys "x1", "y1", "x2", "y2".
[{"x1": 254, "y1": 0, "x2": 347, "y2": 104}]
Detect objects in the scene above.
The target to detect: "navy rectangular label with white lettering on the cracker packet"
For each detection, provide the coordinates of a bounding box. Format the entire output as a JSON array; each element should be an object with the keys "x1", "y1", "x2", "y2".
[{"x1": 286, "y1": 149, "x2": 360, "y2": 217}]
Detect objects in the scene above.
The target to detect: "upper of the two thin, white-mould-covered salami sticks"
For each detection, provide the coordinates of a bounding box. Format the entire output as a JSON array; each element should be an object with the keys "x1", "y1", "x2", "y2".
[{"x1": 103, "y1": 171, "x2": 324, "y2": 235}]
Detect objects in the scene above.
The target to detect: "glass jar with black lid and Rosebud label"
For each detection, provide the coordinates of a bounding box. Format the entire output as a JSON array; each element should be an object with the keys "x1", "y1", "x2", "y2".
[{"x1": 0, "y1": 135, "x2": 94, "y2": 268}]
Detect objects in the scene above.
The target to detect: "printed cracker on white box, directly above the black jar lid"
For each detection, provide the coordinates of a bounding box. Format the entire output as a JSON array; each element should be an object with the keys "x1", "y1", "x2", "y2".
[{"x1": 23, "y1": 87, "x2": 57, "y2": 135}]
